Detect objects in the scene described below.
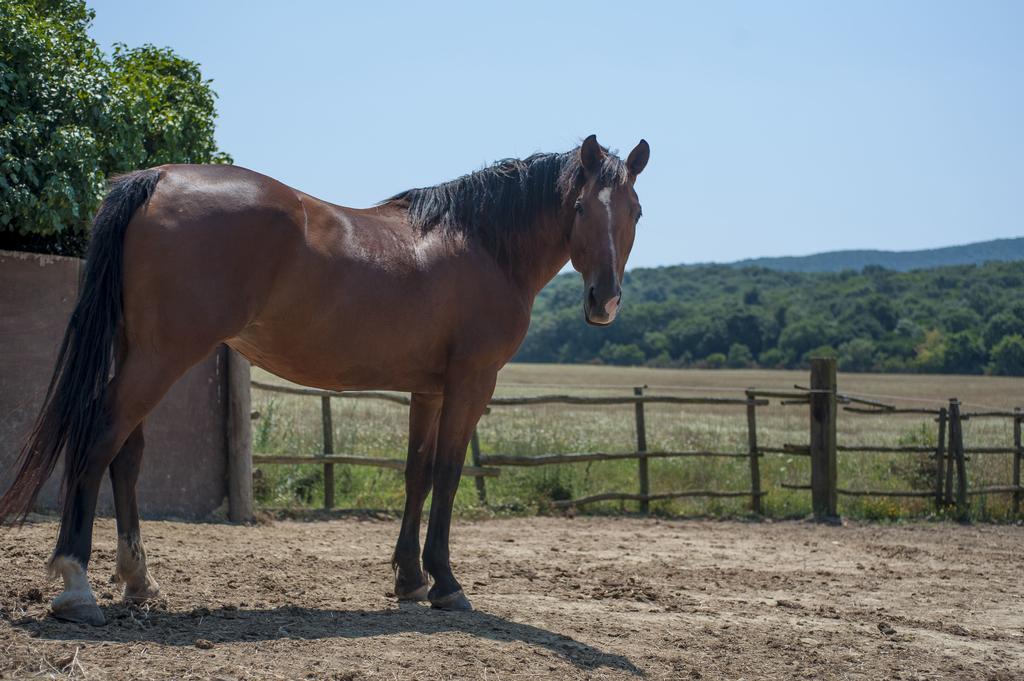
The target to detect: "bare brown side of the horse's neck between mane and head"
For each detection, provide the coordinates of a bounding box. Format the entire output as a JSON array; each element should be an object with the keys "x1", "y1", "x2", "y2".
[{"x1": 512, "y1": 206, "x2": 572, "y2": 297}]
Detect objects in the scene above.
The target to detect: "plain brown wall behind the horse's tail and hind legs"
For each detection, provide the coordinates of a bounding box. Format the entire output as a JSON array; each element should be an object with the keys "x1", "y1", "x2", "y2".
[{"x1": 0, "y1": 251, "x2": 227, "y2": 518}]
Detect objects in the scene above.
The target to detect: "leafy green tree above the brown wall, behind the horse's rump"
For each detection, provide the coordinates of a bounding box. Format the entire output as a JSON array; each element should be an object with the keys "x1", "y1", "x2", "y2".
[{"x1": 0, "y1": 0, "x2": 230, "y2": 254}]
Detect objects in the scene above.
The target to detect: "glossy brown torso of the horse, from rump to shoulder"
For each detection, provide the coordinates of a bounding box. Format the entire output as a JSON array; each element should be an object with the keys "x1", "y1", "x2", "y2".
[{"x1": 125, "y1": 161, "x2": 528, "y2": 391}]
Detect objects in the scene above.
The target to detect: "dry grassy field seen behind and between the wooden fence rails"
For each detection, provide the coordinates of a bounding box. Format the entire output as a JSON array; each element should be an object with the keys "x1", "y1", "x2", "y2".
[{"x1": 253, "y1": 365, "x2": 1024, "y2": 520}]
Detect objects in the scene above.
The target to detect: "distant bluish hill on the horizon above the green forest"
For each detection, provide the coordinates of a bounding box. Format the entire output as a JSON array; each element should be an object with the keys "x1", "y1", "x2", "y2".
[{"x1": 729, "y1": 237, "x2": 1024, "y2": 272}]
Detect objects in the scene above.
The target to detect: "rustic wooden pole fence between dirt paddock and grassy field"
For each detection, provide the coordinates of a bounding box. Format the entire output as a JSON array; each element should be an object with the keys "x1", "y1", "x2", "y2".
[{"x1": 241, "y1": 359, "x2": 1024, "y2": 519}]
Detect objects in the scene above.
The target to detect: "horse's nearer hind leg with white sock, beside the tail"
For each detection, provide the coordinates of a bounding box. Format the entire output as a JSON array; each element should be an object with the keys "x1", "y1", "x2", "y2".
[{"x1": 49, "y1": 353, "x2": 202, "y2": 625}]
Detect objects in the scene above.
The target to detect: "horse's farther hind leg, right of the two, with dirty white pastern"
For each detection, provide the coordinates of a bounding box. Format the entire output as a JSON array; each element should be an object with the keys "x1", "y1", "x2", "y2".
[{"x1": 110, "y1": 423, "x2": 160, "y2": 603}]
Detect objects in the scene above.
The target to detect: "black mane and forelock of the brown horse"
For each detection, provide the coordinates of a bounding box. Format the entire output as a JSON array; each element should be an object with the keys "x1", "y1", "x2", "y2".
[{"x1": 383, "y1": 147, "x2": 627, "y2": 265}]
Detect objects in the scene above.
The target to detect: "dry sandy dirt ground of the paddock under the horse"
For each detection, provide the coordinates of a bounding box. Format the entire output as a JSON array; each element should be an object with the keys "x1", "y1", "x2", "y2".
[{"x1": 0, "y1": 517, "x2": 1024, "y2": 680}]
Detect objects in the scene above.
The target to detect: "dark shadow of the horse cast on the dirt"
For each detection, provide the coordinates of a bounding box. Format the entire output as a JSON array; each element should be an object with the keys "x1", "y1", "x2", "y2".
[{"x1": 12, "y1": 603, "x2": 644, "y2": 676}]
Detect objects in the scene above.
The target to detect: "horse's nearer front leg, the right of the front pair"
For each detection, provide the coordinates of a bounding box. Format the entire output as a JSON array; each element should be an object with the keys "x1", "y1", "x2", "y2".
[{"x1": 423, "y1": 369, "x2": 498, "y2": 610}]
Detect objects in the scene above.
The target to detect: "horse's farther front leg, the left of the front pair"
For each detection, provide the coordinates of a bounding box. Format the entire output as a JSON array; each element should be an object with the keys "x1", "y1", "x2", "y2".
[{"x1": 391, "y1": 393, "x2": 443, "y2": 600}]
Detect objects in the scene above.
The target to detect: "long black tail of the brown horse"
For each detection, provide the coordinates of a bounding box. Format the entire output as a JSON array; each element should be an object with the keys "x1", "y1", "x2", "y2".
[{"x1": 0, "y1": 169, "x2": 160, "y2": 522}]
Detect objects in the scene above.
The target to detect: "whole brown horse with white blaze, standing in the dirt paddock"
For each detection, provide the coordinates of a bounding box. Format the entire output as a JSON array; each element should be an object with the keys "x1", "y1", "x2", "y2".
[{"x1": 0, "y1": 135, "x2": 650, "y2": 624}]
